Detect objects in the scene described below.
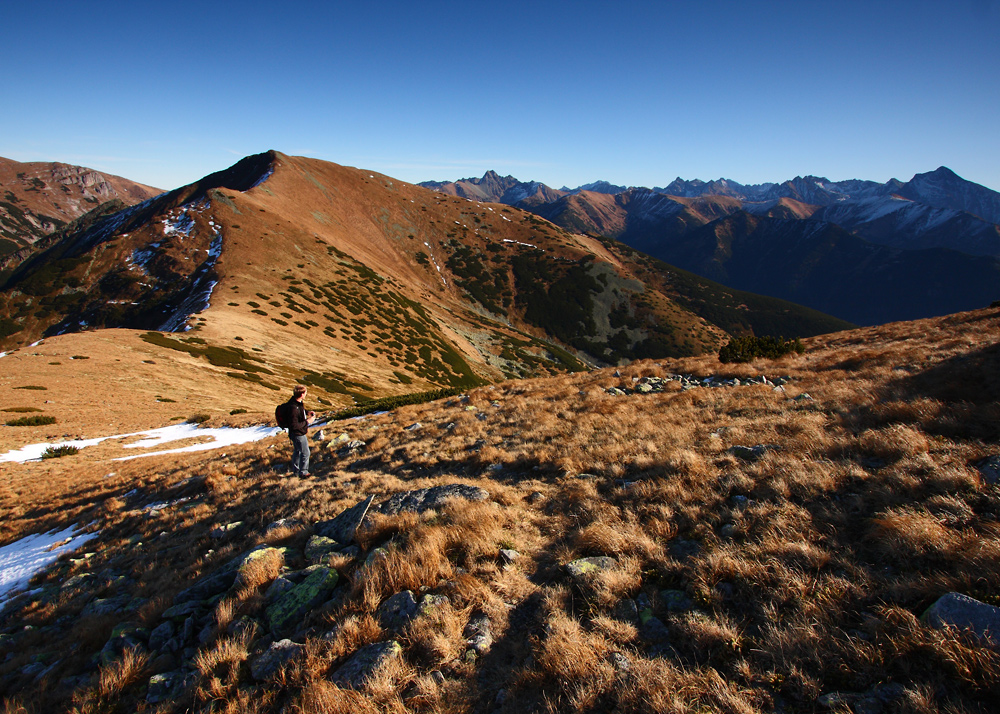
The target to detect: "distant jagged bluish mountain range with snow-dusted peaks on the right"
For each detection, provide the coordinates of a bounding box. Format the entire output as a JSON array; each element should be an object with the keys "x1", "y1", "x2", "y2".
[{"x1": 422, "y1": 167, "x2": 1000, "y2": 324}]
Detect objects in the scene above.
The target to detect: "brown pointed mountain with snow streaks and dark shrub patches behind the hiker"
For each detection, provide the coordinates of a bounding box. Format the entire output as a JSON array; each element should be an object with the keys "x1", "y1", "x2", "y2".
[{"x1": 0, "y1": 152, "x2": 843, "y2": 418}]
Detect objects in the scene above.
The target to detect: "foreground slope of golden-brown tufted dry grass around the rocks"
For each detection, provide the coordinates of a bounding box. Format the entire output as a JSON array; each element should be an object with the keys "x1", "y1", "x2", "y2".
[{"x1": 0, "y1": 309, "x2": 1000, "y2": 714}]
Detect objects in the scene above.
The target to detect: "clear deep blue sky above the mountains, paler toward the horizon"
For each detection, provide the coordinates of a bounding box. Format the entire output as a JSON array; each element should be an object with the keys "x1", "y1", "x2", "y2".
[{"x1": 0, "y1": 0, "x2": 1000, "y2": 189}]
